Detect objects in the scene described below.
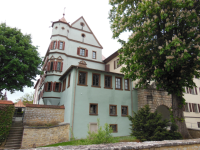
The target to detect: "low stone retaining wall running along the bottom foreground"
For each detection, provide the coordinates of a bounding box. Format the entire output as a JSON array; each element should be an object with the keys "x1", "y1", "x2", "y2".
[{"x1": 22, "y1": 139, "x2": 200, "y2": 150}]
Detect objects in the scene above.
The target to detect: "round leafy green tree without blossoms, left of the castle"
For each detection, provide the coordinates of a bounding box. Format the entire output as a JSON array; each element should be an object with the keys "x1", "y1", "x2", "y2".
[{"x1": 0, "y1": 23, "x2": 42, "y2": 96}]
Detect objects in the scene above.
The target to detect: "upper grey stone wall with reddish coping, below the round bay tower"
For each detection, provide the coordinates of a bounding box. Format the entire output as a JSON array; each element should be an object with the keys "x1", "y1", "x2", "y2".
[{"x1": 23, "y1": 104, "x2": 65, "y2": 126}]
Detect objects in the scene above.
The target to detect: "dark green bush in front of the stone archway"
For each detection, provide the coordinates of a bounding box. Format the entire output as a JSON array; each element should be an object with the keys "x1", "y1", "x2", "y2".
[{"x1": 128, "y1": 105, "x2": 182, "y2": 141}]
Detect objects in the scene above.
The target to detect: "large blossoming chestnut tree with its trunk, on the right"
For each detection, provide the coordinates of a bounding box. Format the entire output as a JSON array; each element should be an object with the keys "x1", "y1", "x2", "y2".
[{"x1": 109, "y1": 0, "x2": 200, "y2": 138}]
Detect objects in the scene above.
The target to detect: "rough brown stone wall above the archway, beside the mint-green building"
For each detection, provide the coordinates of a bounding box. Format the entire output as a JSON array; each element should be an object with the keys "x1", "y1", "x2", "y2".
[{"x1": 135, "y1": 85, "x2": 172, "y2": 112}]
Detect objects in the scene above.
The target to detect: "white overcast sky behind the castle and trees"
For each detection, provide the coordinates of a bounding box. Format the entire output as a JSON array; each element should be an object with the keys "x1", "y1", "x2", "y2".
[{"x1": 0, "y1": 0, "x2": 128, "y2": 102}]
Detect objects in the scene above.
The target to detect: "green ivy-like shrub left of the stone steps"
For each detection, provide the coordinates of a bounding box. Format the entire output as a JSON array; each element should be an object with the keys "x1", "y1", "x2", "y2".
[{"x1": 0, "y1": 105, "x2": 15, "y2": 145}]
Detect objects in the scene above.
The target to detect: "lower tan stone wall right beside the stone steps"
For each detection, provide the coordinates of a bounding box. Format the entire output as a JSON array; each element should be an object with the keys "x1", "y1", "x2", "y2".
[{"x1": 21, "y1": 123, "x2": 69, "y2": 149}]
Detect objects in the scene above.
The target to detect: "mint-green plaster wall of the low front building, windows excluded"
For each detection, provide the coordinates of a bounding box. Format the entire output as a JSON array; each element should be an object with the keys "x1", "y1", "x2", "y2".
[{"x1": 68, "y1": 69, "x2": 137, "y2": 139}]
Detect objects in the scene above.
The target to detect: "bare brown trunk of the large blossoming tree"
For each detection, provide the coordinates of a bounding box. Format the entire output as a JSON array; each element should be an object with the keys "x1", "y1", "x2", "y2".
[{"x1": 172, "y1": 93, "x2": 192, "y2": 139}]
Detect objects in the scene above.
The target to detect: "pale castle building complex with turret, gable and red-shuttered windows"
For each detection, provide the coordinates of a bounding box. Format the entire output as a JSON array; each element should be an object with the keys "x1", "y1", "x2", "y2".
[{"x1": 34, "y1": 16, "x2": 200, "y2": 138}]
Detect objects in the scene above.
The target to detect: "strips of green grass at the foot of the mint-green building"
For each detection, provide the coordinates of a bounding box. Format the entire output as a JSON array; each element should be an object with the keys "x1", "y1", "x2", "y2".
[{"x1": 43, "y1": 136, "x2": 140, "y2": 147}]
